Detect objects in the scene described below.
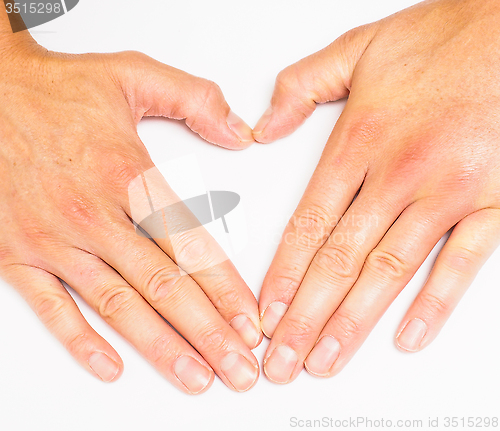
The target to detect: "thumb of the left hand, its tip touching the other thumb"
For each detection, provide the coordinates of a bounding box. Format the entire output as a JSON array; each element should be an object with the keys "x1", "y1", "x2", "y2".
[{"x1": 111, "y1": 51, "x2": 254, "y2": 150}]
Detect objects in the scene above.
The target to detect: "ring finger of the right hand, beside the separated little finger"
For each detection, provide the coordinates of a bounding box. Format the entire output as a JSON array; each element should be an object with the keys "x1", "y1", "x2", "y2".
[{"x1": 305, "y1": 200, "x2": 460, "y2": 377}]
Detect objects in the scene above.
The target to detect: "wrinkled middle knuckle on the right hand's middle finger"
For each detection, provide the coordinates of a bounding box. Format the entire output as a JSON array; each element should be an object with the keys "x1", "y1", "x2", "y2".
[{"x1": 313, "y1": 245, "x2": 359, "y2": 282}]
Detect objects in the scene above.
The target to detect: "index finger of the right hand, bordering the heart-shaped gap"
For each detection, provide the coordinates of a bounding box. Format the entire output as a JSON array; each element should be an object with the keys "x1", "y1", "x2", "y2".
[{"x1": 259, "y1": 114, "x2": 366, "y2": 337}]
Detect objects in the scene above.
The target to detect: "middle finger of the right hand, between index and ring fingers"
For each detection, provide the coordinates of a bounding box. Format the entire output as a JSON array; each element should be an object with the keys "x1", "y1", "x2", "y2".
[{"x1": 264, "y1": 186, "x2": 406, "y2": 383}]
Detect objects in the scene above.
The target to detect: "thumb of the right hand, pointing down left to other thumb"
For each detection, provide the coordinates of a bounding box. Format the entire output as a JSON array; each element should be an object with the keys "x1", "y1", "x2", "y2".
[{"x1": 253, "y1": 24, "x2": 376, "y2": 143}]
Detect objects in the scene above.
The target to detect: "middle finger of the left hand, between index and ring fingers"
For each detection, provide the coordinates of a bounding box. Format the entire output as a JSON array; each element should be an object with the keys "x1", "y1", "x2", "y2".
[{"x1": 94, "y1": 215, "x2": 259, "y2": 391}]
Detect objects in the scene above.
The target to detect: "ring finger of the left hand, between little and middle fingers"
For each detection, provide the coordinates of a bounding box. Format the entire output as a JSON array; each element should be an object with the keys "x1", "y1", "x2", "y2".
[{"x1": 55, "y1": 251, "x2": 214, "y2": 394}]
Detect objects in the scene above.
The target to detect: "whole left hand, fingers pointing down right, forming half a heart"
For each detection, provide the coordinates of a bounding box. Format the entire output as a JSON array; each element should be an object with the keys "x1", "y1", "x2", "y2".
[{"x1": 0, "y1": 16, "x2": 261, "y2": 394}]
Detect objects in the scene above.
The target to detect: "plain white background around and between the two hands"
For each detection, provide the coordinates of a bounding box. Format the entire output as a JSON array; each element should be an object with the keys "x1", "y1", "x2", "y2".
[{"x1": 0, "y1": 0, "x2": 500, "y2": 431}]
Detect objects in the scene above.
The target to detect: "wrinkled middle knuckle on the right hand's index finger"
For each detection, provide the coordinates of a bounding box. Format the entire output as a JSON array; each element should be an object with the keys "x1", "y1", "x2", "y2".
[{"x1": 284, "y1": 206, "x2": 332, "y2": 248}]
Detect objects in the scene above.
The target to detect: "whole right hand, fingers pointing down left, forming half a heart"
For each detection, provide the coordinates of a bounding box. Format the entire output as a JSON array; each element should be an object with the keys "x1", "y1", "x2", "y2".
[{"x1": 254, "y1": 0, "x2": 500, "y2": 383}]
